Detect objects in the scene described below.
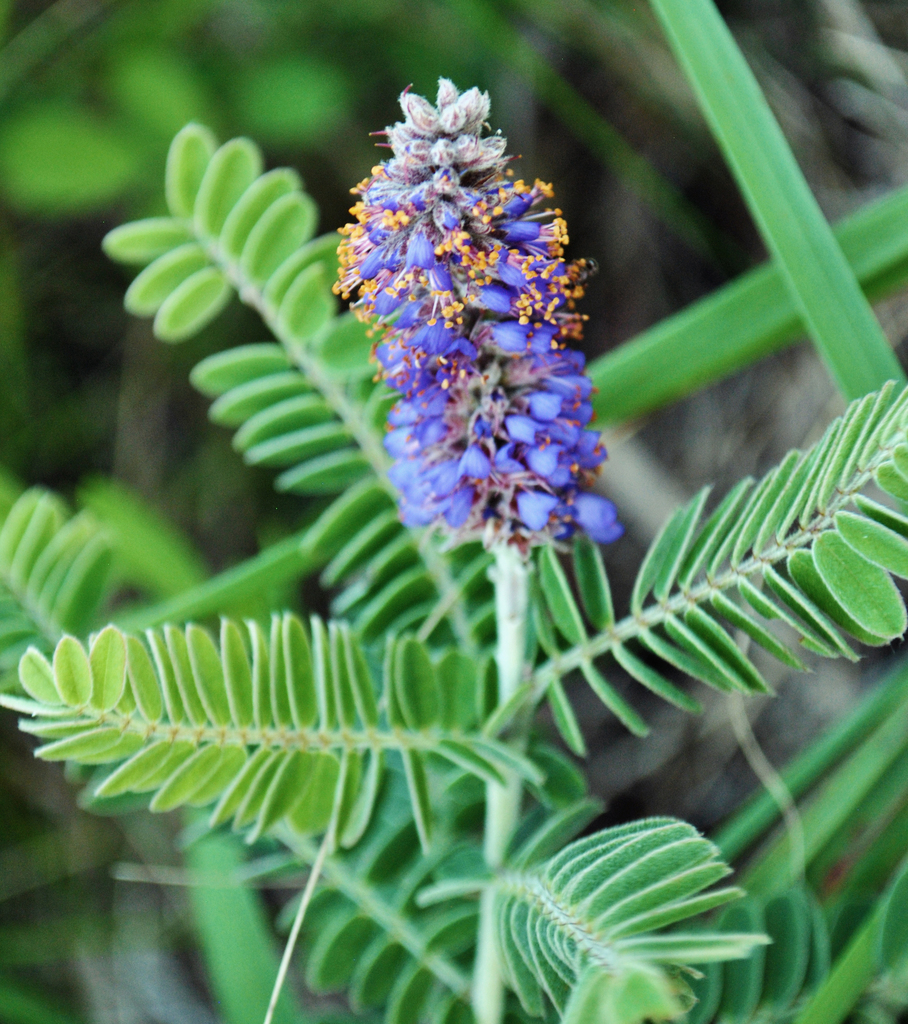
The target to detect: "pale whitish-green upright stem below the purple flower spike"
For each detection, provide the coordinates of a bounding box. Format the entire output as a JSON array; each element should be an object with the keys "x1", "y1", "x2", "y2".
[{"x1": 473, "y1": 545, "x2": 527, "y2": 1024}]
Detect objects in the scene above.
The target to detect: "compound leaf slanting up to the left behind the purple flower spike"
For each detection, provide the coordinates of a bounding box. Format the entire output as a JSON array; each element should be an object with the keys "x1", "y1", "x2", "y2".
[{"x1": 104, "y1": 125, "x2": 493, "y2": 653}]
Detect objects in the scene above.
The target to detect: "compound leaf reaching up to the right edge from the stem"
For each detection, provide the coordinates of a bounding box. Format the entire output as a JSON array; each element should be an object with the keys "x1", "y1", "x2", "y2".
[{"x1": 532, "y1": 383, "x2": 908, "y2": 750}]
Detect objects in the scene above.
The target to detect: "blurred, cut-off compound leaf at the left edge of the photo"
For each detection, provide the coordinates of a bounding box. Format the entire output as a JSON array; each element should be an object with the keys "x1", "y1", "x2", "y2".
[{"x1": 0, "y1": 487, "x2": 112, "y2": 675}]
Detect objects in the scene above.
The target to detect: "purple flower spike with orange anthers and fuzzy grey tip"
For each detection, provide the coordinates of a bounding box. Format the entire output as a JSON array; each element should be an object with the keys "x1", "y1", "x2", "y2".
[{"x1": 336, "y1": 79, "x2": 622, "y2": 551}]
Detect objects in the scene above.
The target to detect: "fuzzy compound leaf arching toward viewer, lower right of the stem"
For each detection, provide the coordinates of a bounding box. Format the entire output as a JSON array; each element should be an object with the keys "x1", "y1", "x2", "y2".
[{"x1": 487, "y1": 818, "x2": 765, "y2": 1024}]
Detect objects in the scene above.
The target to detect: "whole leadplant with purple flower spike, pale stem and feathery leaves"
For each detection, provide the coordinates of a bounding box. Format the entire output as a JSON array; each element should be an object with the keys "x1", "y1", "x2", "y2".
[{"x1": 0, "y1": 48, "x2": 908, "y2": 1024}]
